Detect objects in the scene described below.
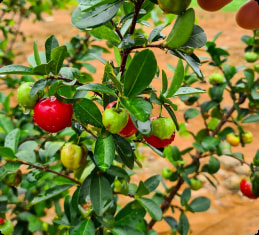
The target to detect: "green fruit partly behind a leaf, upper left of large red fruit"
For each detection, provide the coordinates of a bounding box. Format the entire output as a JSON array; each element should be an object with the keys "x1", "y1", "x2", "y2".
[{"x1": 17, "y1": 82, "x2": 42, "y2": 109}]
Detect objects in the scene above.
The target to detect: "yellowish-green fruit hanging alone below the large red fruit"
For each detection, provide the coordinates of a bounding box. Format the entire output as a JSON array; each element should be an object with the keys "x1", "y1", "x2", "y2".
[{"x1": 60, "y1": 143, "x2": 87, "y2": 170}]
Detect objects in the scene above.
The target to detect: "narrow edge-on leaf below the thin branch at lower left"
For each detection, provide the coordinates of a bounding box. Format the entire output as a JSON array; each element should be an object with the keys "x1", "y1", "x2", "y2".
[{"x1": 29, "y1": 184, "x2": 73, "y2": 206}]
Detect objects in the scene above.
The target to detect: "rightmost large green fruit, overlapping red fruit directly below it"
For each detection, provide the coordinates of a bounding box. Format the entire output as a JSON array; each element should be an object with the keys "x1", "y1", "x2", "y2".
[{"x1": 151, "y1": 117, "x2": 176, "y2": 140}]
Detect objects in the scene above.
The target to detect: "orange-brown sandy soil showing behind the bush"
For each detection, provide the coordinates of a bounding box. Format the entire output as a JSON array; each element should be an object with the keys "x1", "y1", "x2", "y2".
[{"x1": 3, "y1": 6, "x2": 259, "y2": 235}]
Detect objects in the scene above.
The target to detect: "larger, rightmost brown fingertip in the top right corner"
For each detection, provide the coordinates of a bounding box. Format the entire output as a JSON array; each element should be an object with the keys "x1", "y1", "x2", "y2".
[{"x1": 236, "y1": 0, "x2": 259, "y2": 30}]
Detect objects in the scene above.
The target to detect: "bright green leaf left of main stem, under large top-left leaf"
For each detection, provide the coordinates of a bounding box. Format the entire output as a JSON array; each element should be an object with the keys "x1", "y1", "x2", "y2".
[{"x1": 90, "y1": 25, "x2": 121, "y2": 46}]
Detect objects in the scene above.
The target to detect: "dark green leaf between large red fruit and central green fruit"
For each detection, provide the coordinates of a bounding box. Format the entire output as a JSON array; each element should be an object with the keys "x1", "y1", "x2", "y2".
[{"x1": 74, "y1": 99, "x2": 103, "y2": 128}]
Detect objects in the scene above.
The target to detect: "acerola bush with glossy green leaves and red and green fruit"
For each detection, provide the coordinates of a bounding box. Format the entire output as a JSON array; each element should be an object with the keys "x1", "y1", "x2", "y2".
[{"x1": 0, "y1": 0, "x2": 259, "y2": 235}]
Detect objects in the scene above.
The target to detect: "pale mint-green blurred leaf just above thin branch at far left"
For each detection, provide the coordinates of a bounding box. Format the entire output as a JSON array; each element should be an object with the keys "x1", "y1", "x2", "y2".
[{"x1": 15, "y1": 141, "x2": 38, "y2": 163}]
